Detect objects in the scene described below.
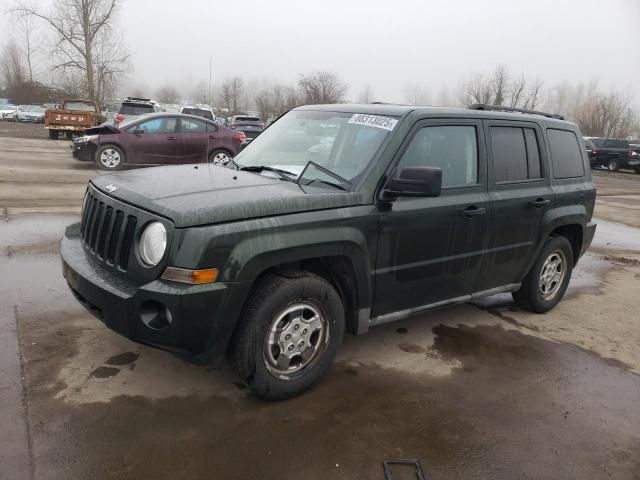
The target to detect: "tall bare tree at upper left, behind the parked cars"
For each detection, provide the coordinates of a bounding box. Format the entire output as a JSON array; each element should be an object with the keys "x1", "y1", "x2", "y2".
[{"x1": 13, "y1": 0, "x2": 129, "y2": 101}]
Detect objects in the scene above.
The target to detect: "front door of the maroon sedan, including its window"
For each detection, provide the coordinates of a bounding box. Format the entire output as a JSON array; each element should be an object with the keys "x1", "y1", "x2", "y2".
[{"x1": 125, "y1": 116, "x2": 178, "y2": 165}]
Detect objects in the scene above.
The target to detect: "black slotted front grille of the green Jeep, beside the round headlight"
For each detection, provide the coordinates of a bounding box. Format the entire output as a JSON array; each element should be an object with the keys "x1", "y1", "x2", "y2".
[{"x1": 80, "y1": 191, "x2": 138, "y2": 271}]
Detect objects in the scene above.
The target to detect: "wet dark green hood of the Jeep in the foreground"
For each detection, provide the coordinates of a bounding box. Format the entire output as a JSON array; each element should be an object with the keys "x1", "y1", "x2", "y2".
[{"x1": 91, "y1": 164, "x2": 364, "y2": 228}]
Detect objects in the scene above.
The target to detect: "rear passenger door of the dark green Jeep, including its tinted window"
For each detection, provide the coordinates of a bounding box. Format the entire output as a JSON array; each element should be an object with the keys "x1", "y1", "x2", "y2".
[{"x1": 475, "y1": 120, "x2": 555, "y2": 292}]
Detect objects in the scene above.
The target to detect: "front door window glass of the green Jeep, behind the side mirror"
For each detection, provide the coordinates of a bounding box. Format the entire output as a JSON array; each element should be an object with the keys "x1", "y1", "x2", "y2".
[{"x1": 399, "y1": 125, "x2": 478, "y2": 187}]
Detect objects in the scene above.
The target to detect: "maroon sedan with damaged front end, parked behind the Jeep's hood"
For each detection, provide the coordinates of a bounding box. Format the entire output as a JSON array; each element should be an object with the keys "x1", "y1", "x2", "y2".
[{"x1": 71, "y1": 113, "x2": 247, "y2": 170}]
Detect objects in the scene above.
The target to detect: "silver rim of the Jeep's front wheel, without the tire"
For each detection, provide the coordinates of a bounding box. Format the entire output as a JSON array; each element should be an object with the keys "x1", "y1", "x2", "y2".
[{"x1": 263, "y1": 301, "x2": 329, "y2": 375}]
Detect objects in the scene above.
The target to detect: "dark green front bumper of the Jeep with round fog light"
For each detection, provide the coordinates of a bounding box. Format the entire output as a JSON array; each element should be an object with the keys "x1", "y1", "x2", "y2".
[{"x1": 60, "y1": 224, "x2": 250, "y2": 362}]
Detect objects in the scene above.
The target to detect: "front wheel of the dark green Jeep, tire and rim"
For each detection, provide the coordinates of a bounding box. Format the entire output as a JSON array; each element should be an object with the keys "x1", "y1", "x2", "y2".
[{"x1": 229, "y1": 271, "x2": 345, "y2": 400}]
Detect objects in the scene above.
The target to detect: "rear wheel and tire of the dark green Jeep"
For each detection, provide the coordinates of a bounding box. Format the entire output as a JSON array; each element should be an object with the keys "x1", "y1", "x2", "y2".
[{"x1": 513, "y1": 236, "x2": 573, "y2": 313}]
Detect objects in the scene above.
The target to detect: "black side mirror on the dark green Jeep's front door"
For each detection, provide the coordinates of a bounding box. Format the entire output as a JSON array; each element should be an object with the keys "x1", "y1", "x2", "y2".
[{"x1": 383, "y1": 167, "x2": 442, "y2": 197}]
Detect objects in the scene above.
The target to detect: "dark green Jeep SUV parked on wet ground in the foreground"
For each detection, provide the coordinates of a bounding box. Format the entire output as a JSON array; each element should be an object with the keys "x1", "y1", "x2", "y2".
[{"x1": 61, "y1": 104, "x2": 596, "y2": 398}]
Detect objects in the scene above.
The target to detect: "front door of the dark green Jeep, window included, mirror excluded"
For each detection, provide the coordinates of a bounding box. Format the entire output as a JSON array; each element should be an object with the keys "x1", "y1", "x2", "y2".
[{"x1": 372, "y1": 120, "x2": 491, "y2": 317}]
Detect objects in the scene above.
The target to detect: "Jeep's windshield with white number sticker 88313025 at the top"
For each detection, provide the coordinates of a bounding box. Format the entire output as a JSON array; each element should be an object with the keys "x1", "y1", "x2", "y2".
[{"x1": 235, "y1": 110, "x2": 397, "y2": 188}]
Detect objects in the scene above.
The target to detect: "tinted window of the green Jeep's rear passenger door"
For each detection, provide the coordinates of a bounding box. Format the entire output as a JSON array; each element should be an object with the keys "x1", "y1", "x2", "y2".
[{"x1": 491, "y1": 127, "x2": 542, "y2": 183}]
